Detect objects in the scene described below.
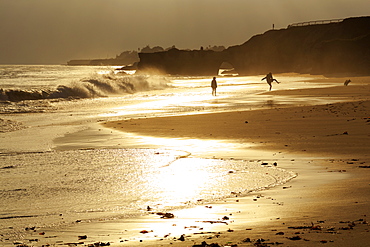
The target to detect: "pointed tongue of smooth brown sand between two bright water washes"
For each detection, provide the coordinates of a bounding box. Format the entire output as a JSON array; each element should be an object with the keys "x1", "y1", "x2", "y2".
[{"x1": 103, "y1": 92, "x2": 370, "y2": 157}]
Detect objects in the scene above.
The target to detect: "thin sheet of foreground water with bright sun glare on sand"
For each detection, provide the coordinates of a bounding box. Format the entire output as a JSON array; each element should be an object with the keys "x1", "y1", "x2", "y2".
[{"x1": 0, "y1": 149, "x2": 294, "y2": 244}]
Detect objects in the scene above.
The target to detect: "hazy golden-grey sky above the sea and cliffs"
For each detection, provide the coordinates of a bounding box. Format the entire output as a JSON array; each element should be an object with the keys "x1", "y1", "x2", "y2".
[{"x1": 0, "y1": 0, "x2": 370, "y2": 64}]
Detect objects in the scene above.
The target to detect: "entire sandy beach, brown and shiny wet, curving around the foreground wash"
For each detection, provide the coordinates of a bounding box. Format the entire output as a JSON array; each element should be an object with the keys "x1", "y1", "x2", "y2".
[{"x1": 12, "y1": 78, "x2": 370, "y2": 247}]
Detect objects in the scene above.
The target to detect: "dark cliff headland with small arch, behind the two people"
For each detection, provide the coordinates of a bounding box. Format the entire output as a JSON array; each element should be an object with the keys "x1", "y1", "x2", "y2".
[{"x1": 139, "y1": 17, "x2": 370, "y2": 75}]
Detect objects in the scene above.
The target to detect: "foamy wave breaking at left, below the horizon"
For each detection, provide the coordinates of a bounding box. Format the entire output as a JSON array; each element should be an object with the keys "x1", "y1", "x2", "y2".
[{"x1": 0, "y1": 74, "x2": 170, "y2": 102}]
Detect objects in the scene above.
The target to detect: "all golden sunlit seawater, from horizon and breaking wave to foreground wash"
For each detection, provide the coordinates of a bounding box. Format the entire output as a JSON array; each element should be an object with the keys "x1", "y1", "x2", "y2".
[{"x1": 0, "y1": 65, "x2": 336, "y2": 246}]
